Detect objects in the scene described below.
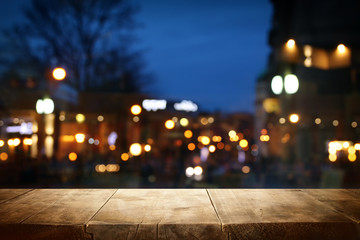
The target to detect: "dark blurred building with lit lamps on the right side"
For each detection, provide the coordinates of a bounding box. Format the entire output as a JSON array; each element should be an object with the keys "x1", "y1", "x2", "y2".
[{"x1": 255, "y1": 0, "x2": 360, "y2": 186}]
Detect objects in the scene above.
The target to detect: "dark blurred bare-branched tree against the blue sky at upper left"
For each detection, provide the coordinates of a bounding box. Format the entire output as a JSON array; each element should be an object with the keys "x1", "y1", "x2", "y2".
[{"x1": 1, "y1": 0, "x2": 150, "y2": 92}]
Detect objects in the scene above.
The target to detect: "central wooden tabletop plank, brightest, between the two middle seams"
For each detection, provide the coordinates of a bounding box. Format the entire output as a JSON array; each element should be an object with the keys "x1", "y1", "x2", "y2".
[{"x1": 87, "y1": 189, "x2": 224, "y2": 239}]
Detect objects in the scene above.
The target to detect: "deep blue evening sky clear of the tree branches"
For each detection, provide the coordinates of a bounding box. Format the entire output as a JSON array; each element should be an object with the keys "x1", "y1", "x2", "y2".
[{"x1": 0, "y1": 0, "x2": 271, "y2": 112}]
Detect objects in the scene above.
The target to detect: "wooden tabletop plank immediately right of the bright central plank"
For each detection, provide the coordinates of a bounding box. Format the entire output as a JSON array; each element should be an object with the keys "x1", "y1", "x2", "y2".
[{"x1": 208, "y1": 189, "x2": 359, "y2": 239}]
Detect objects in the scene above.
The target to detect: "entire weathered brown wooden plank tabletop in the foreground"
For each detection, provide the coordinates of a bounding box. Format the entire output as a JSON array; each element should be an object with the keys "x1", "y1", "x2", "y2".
[{"x1": 0, "y1": 189, "x2": 360, "y2": 240}]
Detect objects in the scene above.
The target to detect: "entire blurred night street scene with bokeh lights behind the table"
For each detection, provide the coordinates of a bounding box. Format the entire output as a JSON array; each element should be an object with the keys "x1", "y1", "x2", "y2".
[{"x1": 0, "y1": 0, "x2": 360, "y2": 188}]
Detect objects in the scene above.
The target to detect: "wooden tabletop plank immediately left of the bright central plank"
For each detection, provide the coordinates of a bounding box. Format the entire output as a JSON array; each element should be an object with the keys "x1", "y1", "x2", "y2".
[{"x1": 0, "y1": 189, "x2": 116, "y2": 239}]
